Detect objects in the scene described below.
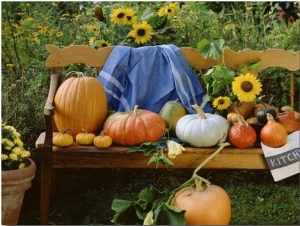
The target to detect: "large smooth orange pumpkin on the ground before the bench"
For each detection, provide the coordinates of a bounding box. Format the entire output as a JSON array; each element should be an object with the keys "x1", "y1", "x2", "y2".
[{"x1": 171, "y1": 184, "x2": 231, "y2": 225}]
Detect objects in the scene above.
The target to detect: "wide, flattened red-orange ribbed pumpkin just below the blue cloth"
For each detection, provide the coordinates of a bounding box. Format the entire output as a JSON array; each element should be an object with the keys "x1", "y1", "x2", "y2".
[{"x1": 103, "y1": 105, "x2": 166, "y2": 146}]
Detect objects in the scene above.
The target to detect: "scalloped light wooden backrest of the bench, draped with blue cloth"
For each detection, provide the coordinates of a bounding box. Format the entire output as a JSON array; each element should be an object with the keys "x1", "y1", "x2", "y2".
[{"x1": 45, "y1": 45, "x2": 300, "y2": 113}]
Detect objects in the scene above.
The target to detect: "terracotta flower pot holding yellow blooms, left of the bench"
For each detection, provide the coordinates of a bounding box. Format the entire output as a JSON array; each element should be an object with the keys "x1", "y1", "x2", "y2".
[{"x1": 1, "y1": 159, "x2": 36, "y2": 225}]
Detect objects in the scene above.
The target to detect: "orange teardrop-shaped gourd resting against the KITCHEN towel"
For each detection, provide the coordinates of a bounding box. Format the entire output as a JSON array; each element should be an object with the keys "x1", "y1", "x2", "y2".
[{"x1": 260, "y1": 113, "x2": 288, "y2": 148}]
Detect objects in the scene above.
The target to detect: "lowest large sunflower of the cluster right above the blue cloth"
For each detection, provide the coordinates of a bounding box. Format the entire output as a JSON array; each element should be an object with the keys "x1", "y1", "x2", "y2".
[{"x1": 129, "y1": 21, "x2": 153, "y2": 44}]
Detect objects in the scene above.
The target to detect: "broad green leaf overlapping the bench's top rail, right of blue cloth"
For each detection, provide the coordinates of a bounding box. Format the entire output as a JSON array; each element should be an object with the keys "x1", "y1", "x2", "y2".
[{"x1": 197, "y1": 39, "x2": 225, "y2": 60}]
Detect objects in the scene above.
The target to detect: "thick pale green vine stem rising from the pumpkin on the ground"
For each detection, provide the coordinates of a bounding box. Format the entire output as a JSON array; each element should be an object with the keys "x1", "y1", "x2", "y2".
[{"x1": 167, "y1": 142, "x2": 230, "y2": 204}]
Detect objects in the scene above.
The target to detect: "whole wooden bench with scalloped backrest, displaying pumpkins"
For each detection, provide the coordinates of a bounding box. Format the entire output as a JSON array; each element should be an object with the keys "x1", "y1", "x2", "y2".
[{"x1": 36, "y1": 45, "x2": 299, "y2": 224}]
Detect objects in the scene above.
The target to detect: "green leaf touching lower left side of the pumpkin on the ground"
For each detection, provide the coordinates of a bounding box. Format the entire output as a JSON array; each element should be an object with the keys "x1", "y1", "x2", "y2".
[{"x1": 154, "y1": 203, "x2": 186, "y2": 225}]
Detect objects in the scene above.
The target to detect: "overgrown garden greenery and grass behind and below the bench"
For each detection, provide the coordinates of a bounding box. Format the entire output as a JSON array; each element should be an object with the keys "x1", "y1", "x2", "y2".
[{"x1": 1, "y1": 1, "x2": 300, "y2": 225}]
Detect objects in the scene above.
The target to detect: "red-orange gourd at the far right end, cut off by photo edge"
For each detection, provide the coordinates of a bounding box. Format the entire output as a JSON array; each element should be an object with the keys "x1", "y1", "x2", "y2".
[{"x1": 278, "y1": 106, "x2": 300, "y2": 134}]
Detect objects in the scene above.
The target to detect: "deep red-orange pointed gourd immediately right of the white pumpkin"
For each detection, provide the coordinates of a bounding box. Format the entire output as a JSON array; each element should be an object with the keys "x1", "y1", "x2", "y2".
[{"x1": 228, "y1": 115, "x2": 256, "y2": 148}]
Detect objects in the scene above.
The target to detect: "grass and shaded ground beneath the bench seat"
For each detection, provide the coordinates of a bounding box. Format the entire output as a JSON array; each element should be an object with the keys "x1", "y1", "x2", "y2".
[{"x1": 19, "y1": 165, "x2": 300, "y2": 225}]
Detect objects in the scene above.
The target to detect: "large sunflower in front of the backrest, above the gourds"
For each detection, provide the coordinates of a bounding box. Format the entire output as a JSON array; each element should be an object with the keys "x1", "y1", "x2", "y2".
[{"x1": 232, "y1": 73, "x2": 262, "y2": 102}]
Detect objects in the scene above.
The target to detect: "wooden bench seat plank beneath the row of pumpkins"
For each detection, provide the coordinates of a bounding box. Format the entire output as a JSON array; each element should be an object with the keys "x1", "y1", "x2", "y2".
[{"x1": 36, "y1": 133, "x2": 268, "y2": 169}]
